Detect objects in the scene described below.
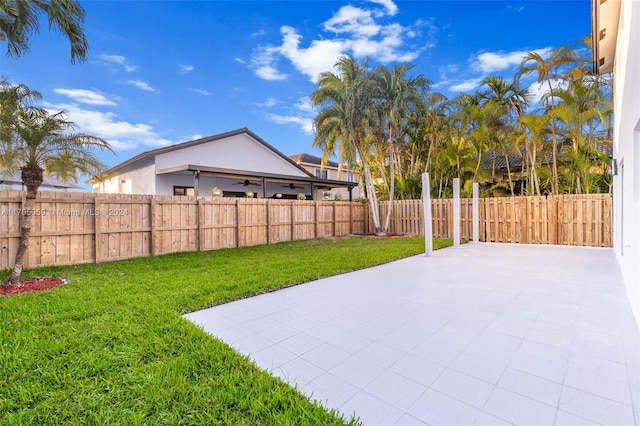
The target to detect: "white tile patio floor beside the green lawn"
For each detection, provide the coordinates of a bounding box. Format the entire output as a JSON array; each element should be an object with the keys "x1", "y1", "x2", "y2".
[{"x1": 186, "y1": 244, "x2": 640, "y2": 426}]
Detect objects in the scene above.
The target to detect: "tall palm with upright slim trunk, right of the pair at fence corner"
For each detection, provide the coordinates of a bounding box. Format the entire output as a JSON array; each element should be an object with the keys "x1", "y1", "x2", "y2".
[{"x1": 375, "y1": 63, "x2": 429, "y2": 232}]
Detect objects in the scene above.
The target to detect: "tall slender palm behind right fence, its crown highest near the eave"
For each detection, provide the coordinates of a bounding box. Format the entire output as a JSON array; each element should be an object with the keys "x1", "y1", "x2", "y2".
[{"x1": 516, "y1": 47, "x2": 578, "y2": 194}]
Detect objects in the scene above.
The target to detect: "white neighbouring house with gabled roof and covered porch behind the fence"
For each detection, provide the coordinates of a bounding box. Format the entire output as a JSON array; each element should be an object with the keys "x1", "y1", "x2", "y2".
[{"x1": 88, "y1": 128, "x2": 353, "y2": 199}]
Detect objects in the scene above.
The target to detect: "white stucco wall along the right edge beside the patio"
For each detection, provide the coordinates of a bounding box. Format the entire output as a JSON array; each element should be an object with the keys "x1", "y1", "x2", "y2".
[{"x1": 613, "y1": 0, "x2": 640, "y2": 325}]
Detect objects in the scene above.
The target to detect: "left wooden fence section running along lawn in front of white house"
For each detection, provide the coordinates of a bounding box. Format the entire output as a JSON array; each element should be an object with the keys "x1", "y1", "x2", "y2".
[{"x1": 0, "y1": 190, "x2": 368, "y2": 269}]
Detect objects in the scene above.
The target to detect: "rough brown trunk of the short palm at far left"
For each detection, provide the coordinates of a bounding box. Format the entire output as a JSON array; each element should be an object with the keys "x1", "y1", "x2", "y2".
[{"x1": 5, "y1": 164, "x2": 42, "y2": 285}]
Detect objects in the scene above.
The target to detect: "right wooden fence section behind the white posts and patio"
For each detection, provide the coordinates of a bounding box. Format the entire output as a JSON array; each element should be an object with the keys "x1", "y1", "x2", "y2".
[{"x1": 378, "y1": 194, "x2": 612, "y2": 247}]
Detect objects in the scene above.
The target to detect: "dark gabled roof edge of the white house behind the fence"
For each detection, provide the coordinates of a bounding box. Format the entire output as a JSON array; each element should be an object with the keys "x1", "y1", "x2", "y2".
[{"x1": 87, "y1": 127, "x2": 313, "y2": 183}]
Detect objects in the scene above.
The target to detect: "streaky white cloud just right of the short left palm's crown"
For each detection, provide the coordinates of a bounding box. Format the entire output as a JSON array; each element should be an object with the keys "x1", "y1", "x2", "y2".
[{"x1": 45, "y1": 104, "x2": 174, "y2": 151}]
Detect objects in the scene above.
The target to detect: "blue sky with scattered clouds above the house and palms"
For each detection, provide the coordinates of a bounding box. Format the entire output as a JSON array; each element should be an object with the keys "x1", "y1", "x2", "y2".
[{"x1": 0, "y1": 0, "x2": 590, "y2": 188}]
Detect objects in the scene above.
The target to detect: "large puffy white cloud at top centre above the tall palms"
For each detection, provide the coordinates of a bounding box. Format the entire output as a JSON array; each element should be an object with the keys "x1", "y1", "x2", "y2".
[{"x1": 250, "y1": 0, "x2": 433, "y2": 82}]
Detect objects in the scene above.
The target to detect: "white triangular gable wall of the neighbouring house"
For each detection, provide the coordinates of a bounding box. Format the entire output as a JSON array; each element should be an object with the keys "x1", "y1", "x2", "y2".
[{"x1": 156, "y1": 134, "x2": 305, "y2": 176}]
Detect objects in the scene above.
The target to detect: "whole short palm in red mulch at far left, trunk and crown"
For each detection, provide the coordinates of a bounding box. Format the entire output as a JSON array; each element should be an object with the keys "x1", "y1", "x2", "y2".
[{"x1": 0, "y1": 83, "x2": 111, "y2": 285}]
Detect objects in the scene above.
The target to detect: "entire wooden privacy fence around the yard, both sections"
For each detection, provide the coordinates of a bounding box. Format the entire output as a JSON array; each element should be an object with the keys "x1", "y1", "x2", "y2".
[{"x1": 0, "y1": 190, "x2": 612, "y2": 269}]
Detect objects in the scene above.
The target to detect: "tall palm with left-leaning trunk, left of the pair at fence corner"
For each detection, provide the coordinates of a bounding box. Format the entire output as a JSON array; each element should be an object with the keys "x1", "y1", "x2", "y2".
[{"x1": 310, "y1": 56, "x2": 384, "y2": 234}]
